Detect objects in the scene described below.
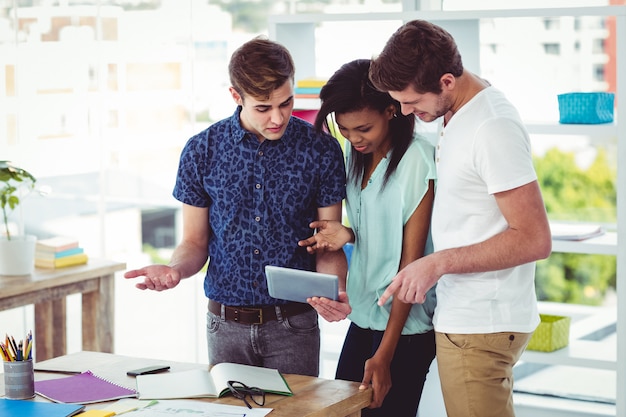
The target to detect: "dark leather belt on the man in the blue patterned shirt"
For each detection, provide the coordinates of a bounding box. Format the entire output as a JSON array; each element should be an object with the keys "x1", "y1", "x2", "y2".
[{"x1": 209, "y1": 300, "x2": 313, "y2": 324}]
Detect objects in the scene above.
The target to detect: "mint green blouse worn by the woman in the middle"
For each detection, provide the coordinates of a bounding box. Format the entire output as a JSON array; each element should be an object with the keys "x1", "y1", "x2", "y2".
[{"x1": 346, "y1": 137, "x2": 436, "y2": 334}]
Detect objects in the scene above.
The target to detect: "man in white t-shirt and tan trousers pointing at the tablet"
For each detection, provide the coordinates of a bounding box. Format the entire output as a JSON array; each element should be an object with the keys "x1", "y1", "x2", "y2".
[{"x1": 370, "y1": 20, "x2": 552, "y2": 417}]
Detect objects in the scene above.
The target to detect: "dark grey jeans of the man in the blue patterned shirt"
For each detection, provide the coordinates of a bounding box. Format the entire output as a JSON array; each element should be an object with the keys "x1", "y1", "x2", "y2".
[{"x1": 207, "y1": 309, "x2": 320, "y2": 376}]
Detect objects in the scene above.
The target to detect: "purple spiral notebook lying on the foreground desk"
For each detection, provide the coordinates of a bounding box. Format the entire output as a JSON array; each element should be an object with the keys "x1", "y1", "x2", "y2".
[{"x1": 35, "y1": 371, "x2": 137, "y2": 404}]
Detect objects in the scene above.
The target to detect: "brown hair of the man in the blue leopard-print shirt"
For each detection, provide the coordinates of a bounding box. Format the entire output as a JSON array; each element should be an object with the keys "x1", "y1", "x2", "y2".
[{"x1": 228, "y1": 36, "x2": 295, "y2": 100}]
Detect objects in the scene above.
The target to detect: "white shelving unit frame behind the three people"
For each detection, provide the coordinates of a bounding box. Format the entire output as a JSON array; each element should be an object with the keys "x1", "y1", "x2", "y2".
[{"x1": 269, "y1": 6, "x2": 626, "y2": 417}]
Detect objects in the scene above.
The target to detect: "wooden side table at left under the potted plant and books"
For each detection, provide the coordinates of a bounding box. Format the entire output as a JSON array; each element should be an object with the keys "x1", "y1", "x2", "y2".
[{"x1": 0, "y1": 259, "x2": 126, "y2": 361}]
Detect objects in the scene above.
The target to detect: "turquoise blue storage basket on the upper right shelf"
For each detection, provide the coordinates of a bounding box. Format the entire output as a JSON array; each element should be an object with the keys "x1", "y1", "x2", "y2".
[{"x1": 557, "y1": 93, "x2": 615, "y2": 124}]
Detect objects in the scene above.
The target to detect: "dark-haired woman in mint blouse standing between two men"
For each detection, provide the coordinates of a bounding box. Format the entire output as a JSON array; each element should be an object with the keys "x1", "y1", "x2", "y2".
[{"x1": 300, "y1": 59, "x2": 435, "y2": 417}]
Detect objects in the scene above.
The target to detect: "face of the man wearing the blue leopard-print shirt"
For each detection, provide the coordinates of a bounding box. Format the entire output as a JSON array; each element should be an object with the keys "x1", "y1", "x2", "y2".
[{"x1": 230, "y1": 81, "x2": 293, "y2": 142}]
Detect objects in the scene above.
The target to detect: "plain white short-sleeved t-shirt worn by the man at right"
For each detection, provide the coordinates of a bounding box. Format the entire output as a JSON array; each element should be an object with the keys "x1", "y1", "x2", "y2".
[{"x1": 432, "y1": 87, "x2": 539, "y2": 334}]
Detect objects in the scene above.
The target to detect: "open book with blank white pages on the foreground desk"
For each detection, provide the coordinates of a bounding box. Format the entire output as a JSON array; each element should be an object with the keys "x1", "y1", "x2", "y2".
[{"x1": 137, "y1": 362, "x2": 293, "y2": 400}]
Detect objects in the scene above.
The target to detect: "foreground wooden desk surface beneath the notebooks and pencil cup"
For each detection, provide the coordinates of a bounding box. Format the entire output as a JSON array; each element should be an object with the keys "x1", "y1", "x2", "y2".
[{"x1": 0, "y1": 351, "x2": 372, "y2": 417}]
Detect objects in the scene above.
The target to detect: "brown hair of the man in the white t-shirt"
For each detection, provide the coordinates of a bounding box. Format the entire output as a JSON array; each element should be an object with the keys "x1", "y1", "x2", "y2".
[{"x1": 370, "y1": 20, "x2": 463, "y2": 94}]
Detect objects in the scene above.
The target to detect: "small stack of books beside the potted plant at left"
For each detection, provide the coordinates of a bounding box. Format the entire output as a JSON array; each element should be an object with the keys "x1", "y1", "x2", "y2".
[{"x1": 35, "y1": 236, "x2": 88, "y2": 268}]
